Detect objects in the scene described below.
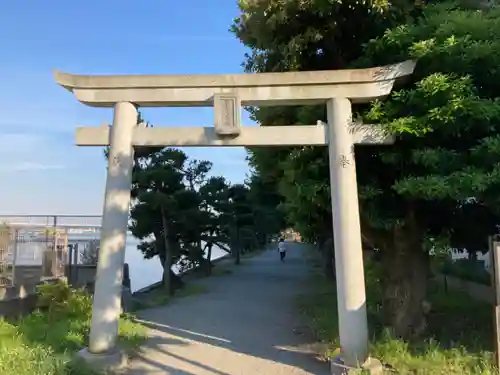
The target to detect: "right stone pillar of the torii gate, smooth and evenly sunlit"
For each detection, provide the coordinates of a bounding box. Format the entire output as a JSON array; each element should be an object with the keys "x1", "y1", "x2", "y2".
[{"x1": 327, "y1": 98, "x2": 368, "y2": 366}]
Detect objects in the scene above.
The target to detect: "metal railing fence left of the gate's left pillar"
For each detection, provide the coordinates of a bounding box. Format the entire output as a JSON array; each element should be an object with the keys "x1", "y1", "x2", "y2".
[{"x1": 0, "y1": 215, "x2": 101, "y2": 287}]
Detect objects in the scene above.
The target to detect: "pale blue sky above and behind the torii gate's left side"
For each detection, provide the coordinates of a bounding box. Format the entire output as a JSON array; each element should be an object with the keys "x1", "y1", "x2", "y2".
[{"x1": 0, "y1": 0, "x2": 254, "y2": 214}]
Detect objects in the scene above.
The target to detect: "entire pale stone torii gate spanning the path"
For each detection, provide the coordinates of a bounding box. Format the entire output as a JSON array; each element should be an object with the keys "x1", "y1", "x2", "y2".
[{"x1": 54, "y1": 61, "x2": 415, "y2": 374}]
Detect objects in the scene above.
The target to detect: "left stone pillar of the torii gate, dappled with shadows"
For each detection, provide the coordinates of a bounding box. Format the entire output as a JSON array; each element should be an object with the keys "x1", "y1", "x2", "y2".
[{"x1": 88, "y1": 102, "x2": 137, "y2": 354}]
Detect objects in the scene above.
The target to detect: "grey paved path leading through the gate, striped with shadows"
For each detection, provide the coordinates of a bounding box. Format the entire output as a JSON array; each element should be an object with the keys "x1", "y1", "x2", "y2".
[{"x1": 127, "y1": 244, "x2": 329, "y2": 375}]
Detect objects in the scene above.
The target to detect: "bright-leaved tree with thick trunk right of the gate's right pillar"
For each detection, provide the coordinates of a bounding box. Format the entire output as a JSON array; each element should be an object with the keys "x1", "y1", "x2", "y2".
[{"x1": 356, "y1": 3, "x2": 500, "y2": 336}]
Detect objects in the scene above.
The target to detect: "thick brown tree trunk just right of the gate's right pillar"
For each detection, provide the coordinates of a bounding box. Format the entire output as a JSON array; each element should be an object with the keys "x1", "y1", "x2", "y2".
[{"x1": 382, "y1": 219, "x2": 430, "y2": 339}]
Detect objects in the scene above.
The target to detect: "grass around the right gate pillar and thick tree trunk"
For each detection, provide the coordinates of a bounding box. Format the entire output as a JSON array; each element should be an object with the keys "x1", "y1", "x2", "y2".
[{"x1": 298, "y1": 262, "x2": 498, "y2": 375}]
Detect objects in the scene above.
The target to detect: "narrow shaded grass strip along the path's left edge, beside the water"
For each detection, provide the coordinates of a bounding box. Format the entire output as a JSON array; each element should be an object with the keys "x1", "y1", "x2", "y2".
[{"x1": 132, "y1": 283, "x2": 208, "y2": 311}]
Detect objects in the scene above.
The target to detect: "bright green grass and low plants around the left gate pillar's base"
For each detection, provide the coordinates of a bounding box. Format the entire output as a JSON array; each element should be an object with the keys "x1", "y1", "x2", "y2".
[{"x1": 0, "y1": 285, "x2": 146, "y2": 375}]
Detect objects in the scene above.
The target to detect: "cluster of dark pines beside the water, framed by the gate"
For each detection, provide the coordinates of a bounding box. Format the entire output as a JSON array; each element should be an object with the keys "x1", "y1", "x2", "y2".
[{"x1": 123, "y1": 118, "x2": 282, "y2": 293}]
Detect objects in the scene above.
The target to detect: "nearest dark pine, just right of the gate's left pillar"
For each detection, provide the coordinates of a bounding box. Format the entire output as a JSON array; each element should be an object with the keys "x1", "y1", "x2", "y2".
[{"x1": 130, "y1": 148, "x2": 219, "y2": 293}]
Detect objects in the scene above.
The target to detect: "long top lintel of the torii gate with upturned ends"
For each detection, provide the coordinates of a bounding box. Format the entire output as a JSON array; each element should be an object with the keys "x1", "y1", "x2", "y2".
[{"x1": 54, "y1": 60, "x2": 415, "y2": 107}]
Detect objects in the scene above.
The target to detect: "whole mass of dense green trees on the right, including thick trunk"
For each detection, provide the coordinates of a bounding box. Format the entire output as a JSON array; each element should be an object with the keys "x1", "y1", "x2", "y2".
[{"x1": 233, "y1": 0, "x2": 500, "y2": 336}]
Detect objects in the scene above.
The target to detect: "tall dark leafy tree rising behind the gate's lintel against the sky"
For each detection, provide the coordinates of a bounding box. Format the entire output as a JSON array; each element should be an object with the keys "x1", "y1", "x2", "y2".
[{"x1": 231, "y1": 0, "x2": 419, "y2": 247}]
